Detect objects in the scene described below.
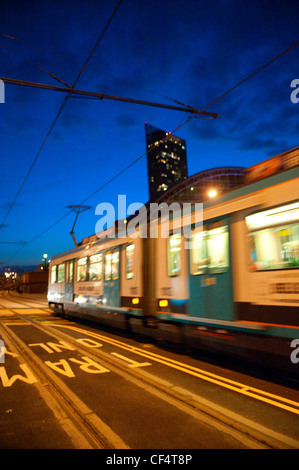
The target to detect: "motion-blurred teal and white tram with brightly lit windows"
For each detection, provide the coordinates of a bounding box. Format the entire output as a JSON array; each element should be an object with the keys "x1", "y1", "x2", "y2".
[{"x1": 48, "y1": 148, "x2": 299, "y2": 375}]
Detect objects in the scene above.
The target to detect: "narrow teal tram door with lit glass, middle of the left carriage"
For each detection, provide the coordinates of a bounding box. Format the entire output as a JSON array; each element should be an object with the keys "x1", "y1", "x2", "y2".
[{"x1": 104, "y1": 247, "x2": 120, "y2": 307}]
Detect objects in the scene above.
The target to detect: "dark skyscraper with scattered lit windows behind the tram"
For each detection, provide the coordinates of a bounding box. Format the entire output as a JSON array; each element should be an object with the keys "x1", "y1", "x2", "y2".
[{"x1": 145, "y1": 123, "x2": 188, "y2": 201}]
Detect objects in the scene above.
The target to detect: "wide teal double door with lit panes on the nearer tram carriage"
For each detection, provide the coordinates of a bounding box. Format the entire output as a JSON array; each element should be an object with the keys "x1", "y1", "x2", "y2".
[{"x1": 189, "y1": 219, "x2": 234, "y2": 320}]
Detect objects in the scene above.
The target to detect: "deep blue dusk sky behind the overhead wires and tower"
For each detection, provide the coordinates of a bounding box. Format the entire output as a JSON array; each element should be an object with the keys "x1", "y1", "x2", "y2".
[{"x1": 0, "y1": 0, "x2": 299, "y2": 265}]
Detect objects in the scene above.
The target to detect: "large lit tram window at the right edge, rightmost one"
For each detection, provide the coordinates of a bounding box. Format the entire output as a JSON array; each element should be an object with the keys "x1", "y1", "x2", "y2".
[{"x1": 246, "y1": 203, "x2": 299, "y2": 271}]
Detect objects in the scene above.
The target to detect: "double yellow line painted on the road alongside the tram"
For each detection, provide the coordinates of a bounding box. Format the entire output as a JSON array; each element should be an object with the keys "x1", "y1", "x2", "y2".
[{"x1": 53, "y1": 324, "x2": 299, "y2": 415}]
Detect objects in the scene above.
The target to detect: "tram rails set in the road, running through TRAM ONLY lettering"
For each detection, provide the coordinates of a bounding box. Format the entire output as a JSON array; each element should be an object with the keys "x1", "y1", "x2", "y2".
[{"x1": 0, "y1": 299, "x2": 299, "y2": 449}]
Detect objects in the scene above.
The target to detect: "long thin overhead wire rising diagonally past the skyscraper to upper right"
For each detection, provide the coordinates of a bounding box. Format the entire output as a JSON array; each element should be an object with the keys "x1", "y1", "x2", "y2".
[{"x1": 2, "y1": 38, "x2": 299, "y2": 261}]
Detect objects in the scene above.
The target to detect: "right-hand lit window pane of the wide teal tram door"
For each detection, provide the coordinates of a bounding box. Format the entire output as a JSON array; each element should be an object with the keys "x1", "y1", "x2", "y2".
[{"x1": 207, "y1": 225, "x2": 229, "y2": 274}]
